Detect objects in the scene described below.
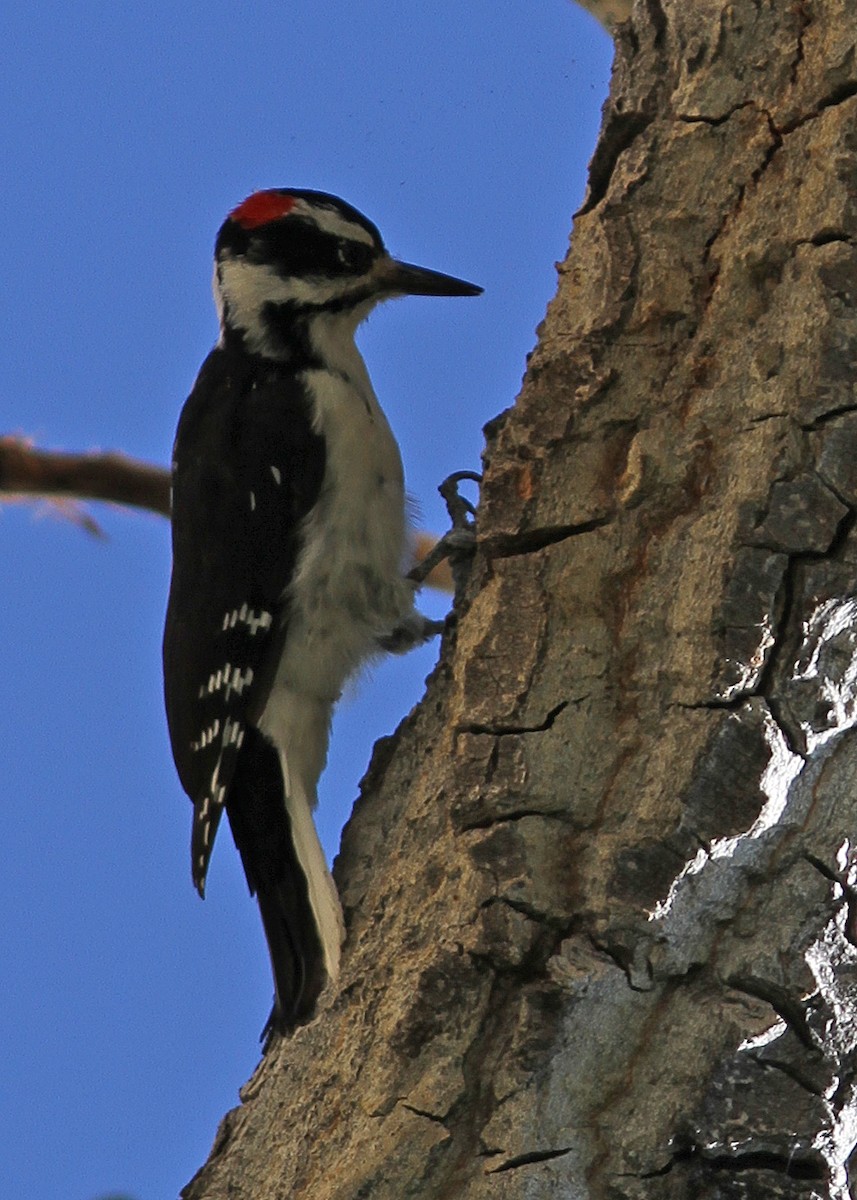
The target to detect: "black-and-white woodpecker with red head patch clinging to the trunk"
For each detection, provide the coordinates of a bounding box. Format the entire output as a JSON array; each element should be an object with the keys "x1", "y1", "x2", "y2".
[{"x1": 163, "y1": 188, "x2": 481, "y2": 1032}]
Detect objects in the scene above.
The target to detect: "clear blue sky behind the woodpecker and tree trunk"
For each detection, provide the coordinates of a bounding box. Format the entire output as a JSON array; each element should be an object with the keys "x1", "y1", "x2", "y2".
[{"x1": 0, "y1": 0, "x2": 611, "y2": 1200}]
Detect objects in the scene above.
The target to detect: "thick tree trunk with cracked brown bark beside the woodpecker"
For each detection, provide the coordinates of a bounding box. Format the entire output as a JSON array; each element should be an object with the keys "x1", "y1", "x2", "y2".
[{"x1": 185, "y1": 0, "x2": 857, "y2": 1200}]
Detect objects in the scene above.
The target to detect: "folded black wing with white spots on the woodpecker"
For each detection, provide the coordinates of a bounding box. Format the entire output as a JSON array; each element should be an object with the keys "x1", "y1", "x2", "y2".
[{"x1": 163, "y1": 349, "x2": 324, "y2": 894}]
